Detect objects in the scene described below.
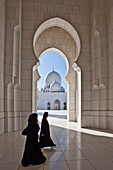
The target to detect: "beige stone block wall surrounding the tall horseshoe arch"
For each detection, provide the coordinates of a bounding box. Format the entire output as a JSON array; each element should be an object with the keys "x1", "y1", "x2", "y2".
[{"x1": 0, "y1": 0, "x2": 113, "y2": 133}]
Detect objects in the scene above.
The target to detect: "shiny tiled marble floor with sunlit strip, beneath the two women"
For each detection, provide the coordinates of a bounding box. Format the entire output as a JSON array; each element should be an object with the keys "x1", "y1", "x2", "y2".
[{"x1": 0, "y1": 117, "x2": 113, "y2": 170}]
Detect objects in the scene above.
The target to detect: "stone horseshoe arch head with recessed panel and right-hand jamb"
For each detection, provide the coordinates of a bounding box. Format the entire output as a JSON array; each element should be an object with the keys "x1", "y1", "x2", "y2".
[{"x1": 33, "y1": 18, "x2": 81, "y2": 127}]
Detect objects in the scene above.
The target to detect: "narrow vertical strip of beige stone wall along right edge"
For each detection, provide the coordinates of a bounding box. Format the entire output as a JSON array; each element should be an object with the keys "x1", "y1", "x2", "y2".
[{"x1": 106, "y1": 0, "x2": 113, "y2": 129}]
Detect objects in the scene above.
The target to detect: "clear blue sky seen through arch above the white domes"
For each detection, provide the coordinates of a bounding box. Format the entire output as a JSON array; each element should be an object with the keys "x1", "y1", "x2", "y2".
[{"x1": 38, "y1": 51, "x2": 67, "y2": 89}]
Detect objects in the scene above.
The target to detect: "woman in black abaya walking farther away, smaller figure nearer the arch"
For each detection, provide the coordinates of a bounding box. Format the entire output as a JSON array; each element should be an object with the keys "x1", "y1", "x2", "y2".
[{"x1": 40, "y1": 112, "x2": 56, "y2": 148}]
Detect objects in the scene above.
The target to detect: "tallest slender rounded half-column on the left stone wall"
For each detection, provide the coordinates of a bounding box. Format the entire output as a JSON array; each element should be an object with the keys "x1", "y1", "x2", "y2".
[{"x1": 13, "y1": 25, "x2": 21, "y2": 130}]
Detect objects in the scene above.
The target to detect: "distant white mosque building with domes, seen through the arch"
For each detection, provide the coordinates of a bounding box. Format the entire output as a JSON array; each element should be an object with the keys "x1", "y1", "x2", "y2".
[{"x1": 37, "y1": 69, "x2": 67, "y2": 110}]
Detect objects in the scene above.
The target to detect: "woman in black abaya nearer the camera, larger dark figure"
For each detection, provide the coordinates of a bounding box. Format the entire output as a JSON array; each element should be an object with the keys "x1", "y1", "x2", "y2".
[{"x1": 21, "y1": 113, "x2": 46, "y2": 167}]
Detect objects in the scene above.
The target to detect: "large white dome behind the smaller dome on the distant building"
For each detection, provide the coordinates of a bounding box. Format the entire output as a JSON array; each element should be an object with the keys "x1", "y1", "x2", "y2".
[{"x1": 45, "y1": 71, "x2": 61, "y2": 85}]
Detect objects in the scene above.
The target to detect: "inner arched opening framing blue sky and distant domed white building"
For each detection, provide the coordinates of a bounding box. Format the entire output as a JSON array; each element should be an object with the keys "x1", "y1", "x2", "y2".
[{"x1": 37, "y1": 48, "x2": 69, "y2": 117}]
